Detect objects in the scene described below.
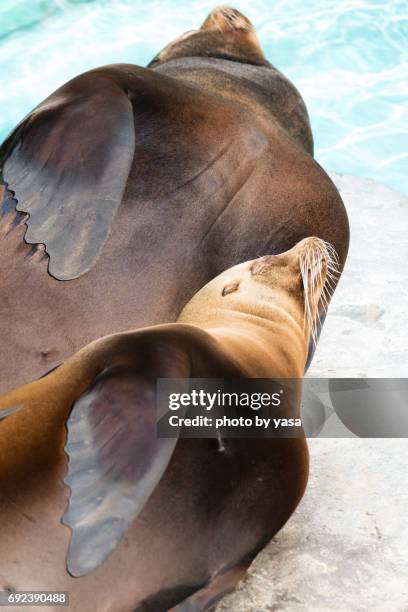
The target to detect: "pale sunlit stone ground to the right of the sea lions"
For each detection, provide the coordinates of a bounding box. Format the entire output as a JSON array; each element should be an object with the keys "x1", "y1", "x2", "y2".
[{"x1": 217, "y1": 174, "x2": 408, "y2": 612}]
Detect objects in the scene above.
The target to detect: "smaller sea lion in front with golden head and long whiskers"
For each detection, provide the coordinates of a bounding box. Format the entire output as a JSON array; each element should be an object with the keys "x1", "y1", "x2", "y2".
[{"x1": 0, "y1": 238, "x2": 337, "y2": 612}]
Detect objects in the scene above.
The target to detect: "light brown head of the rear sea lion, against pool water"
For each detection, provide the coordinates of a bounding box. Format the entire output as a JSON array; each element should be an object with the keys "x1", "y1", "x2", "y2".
[{"x1": 149, "y1": 7, "x2": 270, "y2": 68}]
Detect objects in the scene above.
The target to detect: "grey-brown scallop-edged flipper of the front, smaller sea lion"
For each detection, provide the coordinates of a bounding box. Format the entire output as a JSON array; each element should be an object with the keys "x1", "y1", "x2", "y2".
[{"x1": 63, "y1": 368, "x2": 177, "y2": 576}]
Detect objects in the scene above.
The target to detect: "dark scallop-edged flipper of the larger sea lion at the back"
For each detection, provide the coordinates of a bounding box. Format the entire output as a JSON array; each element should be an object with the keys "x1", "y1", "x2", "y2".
[{"x1": 0, "y1": 70, "x2": 134, "y2": 280}]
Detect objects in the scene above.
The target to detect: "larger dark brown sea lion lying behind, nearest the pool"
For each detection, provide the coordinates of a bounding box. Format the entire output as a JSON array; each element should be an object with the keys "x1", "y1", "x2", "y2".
[{"x1": 0, "y1": 9, "x2": 348, "y2": 393}]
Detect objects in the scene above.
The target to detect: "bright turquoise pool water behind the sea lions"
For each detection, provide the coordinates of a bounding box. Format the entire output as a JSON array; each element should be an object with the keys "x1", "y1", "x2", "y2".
[{"x1": 0, "y1": 0, "x2": 408, "y2": 193}]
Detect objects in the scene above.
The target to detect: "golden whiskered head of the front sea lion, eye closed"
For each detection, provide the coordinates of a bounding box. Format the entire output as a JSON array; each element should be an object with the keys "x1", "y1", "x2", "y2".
[{"x1": 179, "y1": 236, "x2": 339, "y2": 343}]
